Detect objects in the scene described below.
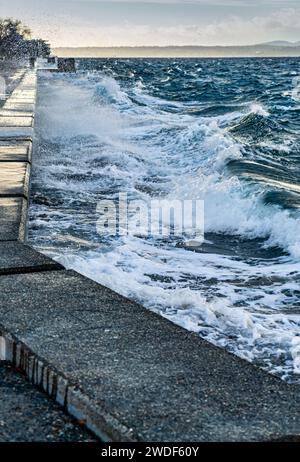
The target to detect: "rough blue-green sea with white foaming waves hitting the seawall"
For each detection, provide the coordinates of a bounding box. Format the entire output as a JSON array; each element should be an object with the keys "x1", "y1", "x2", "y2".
[{"x1": 29, "y1": 59, "x2": 300, "y2": 382}]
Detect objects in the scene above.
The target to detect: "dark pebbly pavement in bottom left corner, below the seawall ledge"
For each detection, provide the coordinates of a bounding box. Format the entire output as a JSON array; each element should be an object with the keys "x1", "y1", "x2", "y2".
[{"x1": 0, "y1": 363, "x2": 95, "y2": 443}]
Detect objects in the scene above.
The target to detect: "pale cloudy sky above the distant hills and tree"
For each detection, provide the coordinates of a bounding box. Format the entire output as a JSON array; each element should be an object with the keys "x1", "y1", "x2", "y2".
[{"x1": 0, "y1": 0, "x2": 300, "y2": 47}]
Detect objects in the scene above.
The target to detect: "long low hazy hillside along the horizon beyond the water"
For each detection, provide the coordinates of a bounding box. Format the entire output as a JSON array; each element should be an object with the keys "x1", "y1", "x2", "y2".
[{"x1": 52, "y1": 41, "x2": 300, "y2": 58}]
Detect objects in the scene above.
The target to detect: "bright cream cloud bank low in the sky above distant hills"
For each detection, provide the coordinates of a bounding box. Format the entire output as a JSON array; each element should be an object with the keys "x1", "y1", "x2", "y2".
[{"x1": 48, "y1": 8, "x2": 300, "y2": 46}]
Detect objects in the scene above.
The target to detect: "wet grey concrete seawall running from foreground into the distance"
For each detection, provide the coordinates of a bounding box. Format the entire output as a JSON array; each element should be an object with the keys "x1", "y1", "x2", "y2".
[{"x1": 0, "y1": 70, "x2": 300, "y2": 442}]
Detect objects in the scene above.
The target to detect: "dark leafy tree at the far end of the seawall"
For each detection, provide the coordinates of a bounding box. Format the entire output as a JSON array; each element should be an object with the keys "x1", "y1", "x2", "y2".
[{"x1": 0, "y1": 18, "x2": 50, "y2": 58}]
